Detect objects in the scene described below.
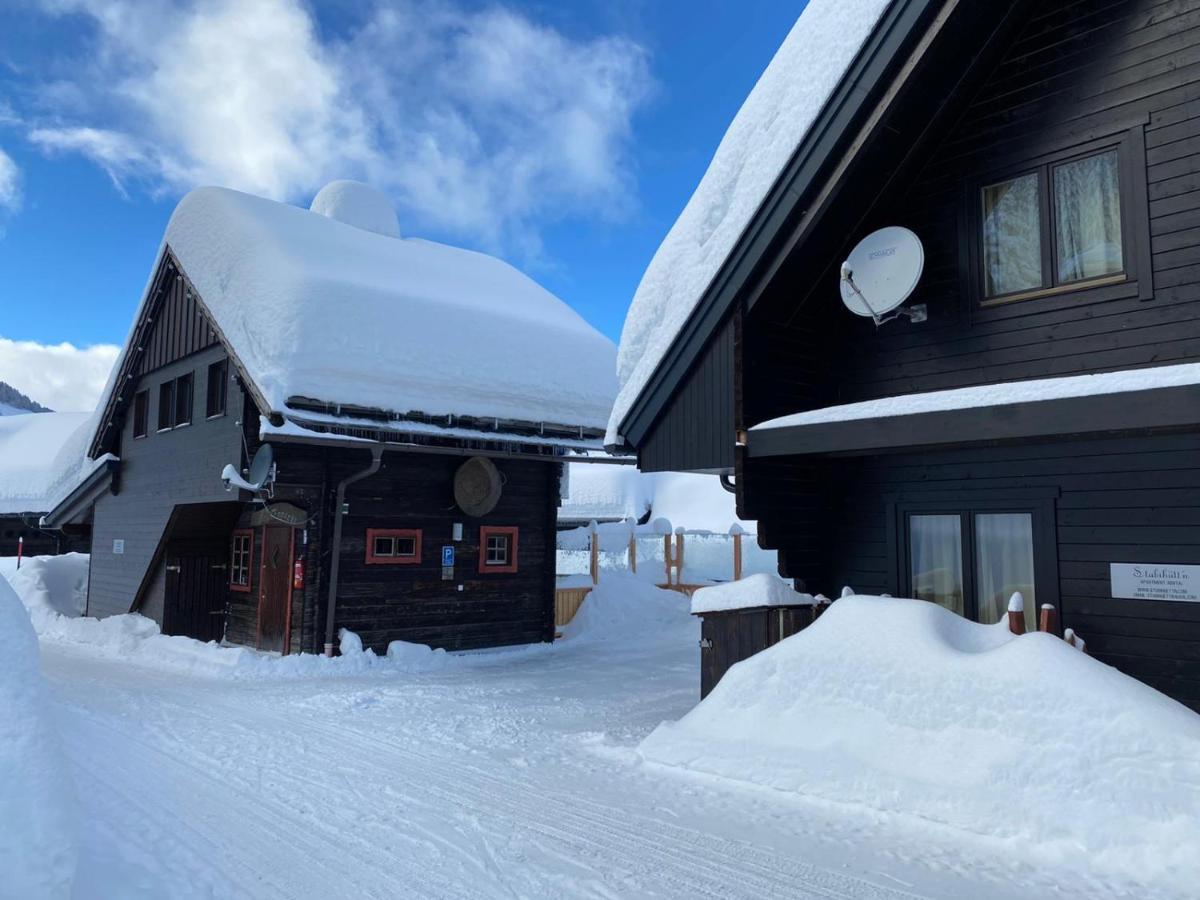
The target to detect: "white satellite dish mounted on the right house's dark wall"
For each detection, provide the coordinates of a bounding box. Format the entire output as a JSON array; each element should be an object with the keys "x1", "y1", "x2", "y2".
[{"x1": 839, "y1": 226, "x2": 925, "y2": 325}]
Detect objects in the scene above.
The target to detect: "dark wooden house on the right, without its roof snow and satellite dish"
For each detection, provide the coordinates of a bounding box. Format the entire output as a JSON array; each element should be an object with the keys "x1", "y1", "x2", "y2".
[{"x1": 616, "y1": 0, "x2": 1200, "y2": 709}]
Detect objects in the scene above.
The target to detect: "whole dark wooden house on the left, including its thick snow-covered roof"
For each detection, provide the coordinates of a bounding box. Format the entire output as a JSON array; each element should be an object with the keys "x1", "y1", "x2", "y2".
[{"x1": 47, "y1": 185, "x2": 614, "y2": 653}]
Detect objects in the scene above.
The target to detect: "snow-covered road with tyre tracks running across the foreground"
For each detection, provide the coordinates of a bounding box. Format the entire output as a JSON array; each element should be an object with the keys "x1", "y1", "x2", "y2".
[{"x1": 35, "y1": 614, "x2": 1171, "y2": 900}]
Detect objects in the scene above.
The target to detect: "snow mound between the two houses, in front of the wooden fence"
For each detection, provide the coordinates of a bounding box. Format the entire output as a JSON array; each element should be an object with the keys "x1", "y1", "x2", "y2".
[{"x1": 562, "y1": 574, "x2": 700, "y2": 644}]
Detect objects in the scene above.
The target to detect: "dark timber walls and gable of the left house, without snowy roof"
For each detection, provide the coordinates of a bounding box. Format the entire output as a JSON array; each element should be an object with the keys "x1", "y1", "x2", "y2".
[{"x1": 52, "y1": 250, "x2": 573, "y2": 653}]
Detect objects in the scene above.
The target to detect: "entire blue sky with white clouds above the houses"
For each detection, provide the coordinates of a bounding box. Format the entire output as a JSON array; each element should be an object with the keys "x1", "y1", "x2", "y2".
[{"x1": 0, "y1": 0, "x2": 803, "y2": 406}]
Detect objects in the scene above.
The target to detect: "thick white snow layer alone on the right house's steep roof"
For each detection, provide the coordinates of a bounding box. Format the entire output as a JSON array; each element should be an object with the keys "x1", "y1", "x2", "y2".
[{"x1": 605, "y1": 0, "x2": 888, "y2": 444}]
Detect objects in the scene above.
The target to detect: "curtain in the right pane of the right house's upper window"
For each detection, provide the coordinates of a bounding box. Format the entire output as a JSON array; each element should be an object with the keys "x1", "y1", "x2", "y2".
[{"x1": 1054, "y1": 150, "x2": 1124, "y2": 282}]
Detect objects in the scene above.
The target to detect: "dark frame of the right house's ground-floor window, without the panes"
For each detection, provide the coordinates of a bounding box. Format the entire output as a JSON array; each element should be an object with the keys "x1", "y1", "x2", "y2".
[{"x1": 888, "y1": 487, "x2": 1060, "y2": 622}]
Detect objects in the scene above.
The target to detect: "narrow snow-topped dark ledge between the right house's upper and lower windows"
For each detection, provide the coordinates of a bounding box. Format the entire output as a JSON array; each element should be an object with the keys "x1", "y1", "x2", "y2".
[{"x1": 746, "y1": 362, "x2": 1200, "y2": 456}]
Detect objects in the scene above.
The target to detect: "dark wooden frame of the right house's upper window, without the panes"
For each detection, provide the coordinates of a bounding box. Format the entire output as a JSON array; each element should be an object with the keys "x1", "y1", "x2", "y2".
[{"x1": 961, "y1": 121, "x2": 1154, "y2": 319}]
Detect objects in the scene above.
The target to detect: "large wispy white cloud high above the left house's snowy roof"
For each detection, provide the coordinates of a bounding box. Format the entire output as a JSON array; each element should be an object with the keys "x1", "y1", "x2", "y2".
[{"x1": 26, "y1": 0, "x2": 652, "y2": 252}]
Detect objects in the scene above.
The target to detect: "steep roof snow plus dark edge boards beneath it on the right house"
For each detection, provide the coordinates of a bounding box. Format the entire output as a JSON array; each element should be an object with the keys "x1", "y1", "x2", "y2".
[{"x1": 606, "y1": 0, "x2": 932, "y2": 444}]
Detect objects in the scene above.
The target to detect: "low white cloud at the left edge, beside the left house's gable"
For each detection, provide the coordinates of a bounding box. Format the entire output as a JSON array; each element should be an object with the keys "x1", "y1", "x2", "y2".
[{"x1": 0, "y1": 337, "x2": 120, "y2": 413}]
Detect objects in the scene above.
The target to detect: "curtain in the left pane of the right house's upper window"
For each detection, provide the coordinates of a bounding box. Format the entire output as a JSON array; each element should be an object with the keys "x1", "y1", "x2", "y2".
[{"x1": 983, "y1": 173, "x2": 1043, "y2": 296}]
